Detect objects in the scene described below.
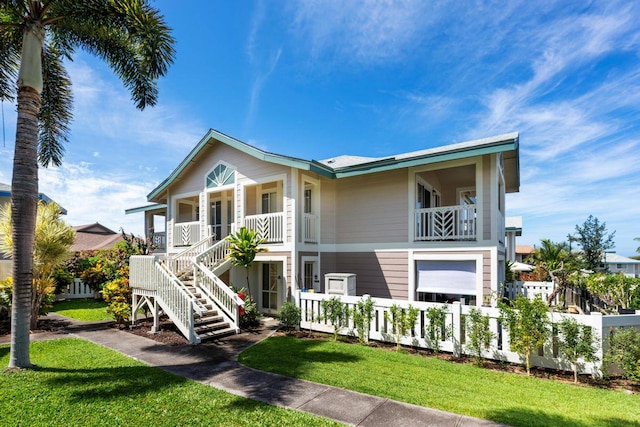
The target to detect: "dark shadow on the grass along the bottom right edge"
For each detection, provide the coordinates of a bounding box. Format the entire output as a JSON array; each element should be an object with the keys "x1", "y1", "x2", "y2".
[{"x1": 487, "y1": 408, "x2": 640, "y2": 427}]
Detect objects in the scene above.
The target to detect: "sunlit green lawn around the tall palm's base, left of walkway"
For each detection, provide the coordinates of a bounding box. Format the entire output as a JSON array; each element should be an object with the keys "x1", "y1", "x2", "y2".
[{"x1": 0, "y1": 339, "x2": 337, "y2": 427}]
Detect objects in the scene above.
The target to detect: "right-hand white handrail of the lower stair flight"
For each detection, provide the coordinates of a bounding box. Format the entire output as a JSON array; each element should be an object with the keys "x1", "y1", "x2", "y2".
[{"x1": 194, "y1": 262, "x2": 244, "y2": 331}]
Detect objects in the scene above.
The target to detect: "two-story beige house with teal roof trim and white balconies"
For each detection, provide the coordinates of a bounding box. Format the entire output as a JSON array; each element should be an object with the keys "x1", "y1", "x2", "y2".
[{"x1": 127, "y1": 130, "x2": 519, "y2": 342}]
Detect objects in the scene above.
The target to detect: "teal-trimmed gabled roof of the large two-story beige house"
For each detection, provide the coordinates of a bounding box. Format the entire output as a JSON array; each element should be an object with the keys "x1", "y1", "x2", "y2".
[{"x1": 147, "y1": 129, "x2": 520, "y2": 201}]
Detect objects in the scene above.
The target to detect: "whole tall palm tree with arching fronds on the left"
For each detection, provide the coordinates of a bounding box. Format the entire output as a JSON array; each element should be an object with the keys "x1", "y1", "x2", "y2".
[{"x1": 0, "y1": 0, "x2": 174, "y2": 368}]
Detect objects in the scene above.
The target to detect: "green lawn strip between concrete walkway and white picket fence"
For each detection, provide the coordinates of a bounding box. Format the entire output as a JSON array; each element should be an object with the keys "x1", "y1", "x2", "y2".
[{"x1": 239, "y1": 336, "x2": 640, "y2": 427}]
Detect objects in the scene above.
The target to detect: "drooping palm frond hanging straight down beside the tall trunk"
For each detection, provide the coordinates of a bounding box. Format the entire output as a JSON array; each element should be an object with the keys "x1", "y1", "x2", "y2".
[{"x1": 38, "y1": 44, "x2": 73, "y2": 167}]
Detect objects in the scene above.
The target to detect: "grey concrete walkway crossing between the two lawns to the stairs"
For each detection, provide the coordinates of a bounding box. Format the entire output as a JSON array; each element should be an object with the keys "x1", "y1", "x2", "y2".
[{"x1": 0, "y1": 313, "x2": 508, "y2": 427}]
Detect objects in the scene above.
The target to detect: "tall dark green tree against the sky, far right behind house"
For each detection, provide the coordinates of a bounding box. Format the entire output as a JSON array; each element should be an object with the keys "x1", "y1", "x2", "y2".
[{"x1": 571, "y1": 215, "x2": 616, "y2": 271}]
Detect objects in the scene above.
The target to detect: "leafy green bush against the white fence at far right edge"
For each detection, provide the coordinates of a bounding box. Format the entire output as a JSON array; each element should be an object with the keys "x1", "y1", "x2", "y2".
[{"x1": 604, "y1": 328, "x2": 640, "y2": 381}]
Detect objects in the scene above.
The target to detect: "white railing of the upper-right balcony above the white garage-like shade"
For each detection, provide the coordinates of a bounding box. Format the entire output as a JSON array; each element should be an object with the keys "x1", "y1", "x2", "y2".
[{"x1": 414, "y1": 205, "x2": 476, "y2": 241}]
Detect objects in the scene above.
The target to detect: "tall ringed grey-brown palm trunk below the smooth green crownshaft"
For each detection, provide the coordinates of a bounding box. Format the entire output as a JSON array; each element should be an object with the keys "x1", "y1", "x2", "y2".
[{"x1": 9, "y1": 87, "x2": 41, "y2": 368}]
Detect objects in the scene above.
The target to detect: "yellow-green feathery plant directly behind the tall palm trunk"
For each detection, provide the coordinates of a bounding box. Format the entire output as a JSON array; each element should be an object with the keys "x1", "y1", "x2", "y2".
[{"x1": 0, "y1": 202, "x2": 76, "y2": 329}]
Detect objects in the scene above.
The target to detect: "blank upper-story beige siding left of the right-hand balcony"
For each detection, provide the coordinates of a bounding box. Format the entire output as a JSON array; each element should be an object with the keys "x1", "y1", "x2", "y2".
[{"x1": 332, "y1": 169, "x2": 409, "y2": 243}]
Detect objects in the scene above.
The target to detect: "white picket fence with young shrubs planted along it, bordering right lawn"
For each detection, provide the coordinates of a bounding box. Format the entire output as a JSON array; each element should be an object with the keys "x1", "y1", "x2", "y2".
[{"x1": 297, "y1": 292, "x2": 640, "y2": 375}]
